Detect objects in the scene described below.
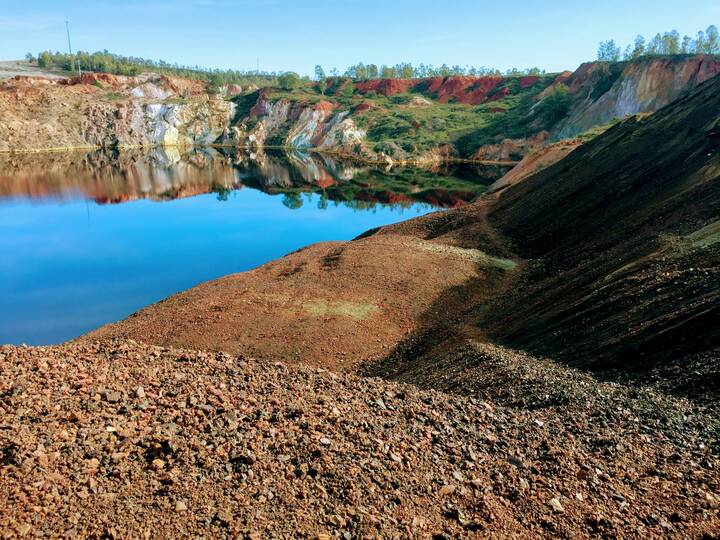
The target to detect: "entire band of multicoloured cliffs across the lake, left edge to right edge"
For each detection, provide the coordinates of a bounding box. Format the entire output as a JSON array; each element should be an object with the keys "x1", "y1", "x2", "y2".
[{"x1": 0, "y1": 56, "x2": 720, "y2": 165}]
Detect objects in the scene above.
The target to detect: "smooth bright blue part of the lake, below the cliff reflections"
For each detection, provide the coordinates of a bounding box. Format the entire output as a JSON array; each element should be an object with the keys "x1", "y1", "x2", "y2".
[{"x1": 0, "y1": 188, "x2": 432, "y2": 345}]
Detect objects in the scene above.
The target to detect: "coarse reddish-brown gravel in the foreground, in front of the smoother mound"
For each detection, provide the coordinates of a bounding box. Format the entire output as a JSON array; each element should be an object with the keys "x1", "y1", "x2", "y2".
[{"x1": 0, "y1": 341, "x2": 720, "y2": 538}]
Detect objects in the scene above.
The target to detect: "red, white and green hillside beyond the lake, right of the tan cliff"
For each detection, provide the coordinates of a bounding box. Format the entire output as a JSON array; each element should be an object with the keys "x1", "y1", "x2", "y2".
[{"x1": 234, "y1": 55, "x2": 720, "y2": 161}]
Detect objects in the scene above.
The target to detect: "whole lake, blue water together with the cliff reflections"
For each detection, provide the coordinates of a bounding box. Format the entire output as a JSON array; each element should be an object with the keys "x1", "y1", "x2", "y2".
[{"x1": 0, "y1": 149, "x2": 505, "y2": 345}]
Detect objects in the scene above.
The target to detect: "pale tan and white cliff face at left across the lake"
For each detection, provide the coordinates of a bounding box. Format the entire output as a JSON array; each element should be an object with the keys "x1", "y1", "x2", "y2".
[{"x1": 0, "y1": 73, "x2": 235, "y2": 151}]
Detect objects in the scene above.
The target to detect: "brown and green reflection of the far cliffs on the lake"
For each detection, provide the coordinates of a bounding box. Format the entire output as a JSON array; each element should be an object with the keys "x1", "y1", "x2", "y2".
[{"x1": 0, "y1": 148, "x2": 502, "y2": 207}]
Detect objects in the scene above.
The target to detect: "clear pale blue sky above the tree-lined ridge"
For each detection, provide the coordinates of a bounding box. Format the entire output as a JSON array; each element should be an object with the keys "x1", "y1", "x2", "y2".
[{"x1": 0, "y1": 0, "x2": 720, "y2": 74}]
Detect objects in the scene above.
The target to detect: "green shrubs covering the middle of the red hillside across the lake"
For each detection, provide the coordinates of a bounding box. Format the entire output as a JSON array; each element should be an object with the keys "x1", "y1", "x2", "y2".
[{"x1": 258, "y1": 70, "x2": 571, "y2": 159}]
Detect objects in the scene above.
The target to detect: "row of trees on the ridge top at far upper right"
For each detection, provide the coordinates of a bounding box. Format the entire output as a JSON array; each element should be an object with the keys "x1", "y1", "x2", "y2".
[{"x1": 598, "y1": 25, "x2": 720, "y2": 62}]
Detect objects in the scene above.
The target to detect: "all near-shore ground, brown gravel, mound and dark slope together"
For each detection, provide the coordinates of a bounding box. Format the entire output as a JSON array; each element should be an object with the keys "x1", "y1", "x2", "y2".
[{"x1": 0, "y1": 57, "x2": 720, "y2": 539}]
